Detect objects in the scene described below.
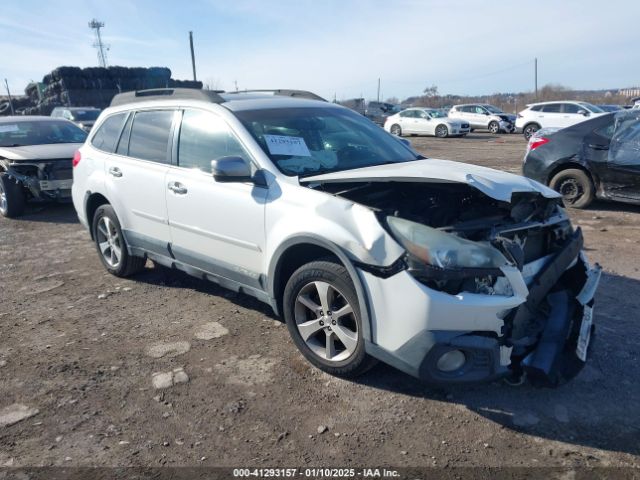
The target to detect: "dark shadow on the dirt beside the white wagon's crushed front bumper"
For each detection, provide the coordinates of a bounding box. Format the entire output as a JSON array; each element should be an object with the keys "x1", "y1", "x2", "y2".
[{"x1": 357, "y1": 274, "x2": 640, "y2": 455}]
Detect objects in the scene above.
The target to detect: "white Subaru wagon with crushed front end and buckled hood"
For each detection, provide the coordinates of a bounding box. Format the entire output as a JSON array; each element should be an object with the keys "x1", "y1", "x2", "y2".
[{"x1": 73, "y1": 89, "x2": 600, "y2": 386}]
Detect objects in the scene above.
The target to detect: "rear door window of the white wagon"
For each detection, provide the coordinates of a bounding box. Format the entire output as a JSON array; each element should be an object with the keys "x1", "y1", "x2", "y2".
[{"x1": 129, "y1": 110, "x2": 174, "y2": 163}]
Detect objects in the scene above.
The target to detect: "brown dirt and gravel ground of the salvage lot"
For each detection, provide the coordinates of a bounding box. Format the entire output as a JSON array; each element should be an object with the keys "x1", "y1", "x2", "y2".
[{"x1": 0, "y1": 133, "x2": 640, "y2": 467}]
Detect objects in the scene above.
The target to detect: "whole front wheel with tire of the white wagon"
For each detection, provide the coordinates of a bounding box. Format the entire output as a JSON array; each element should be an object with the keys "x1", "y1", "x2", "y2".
[{"x1": 283, "y1": 259, "x2": 376, "y2": 377}]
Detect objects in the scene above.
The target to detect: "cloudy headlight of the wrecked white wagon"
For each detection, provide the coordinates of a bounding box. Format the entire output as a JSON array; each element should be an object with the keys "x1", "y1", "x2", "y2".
[{"x1": 387, "y1": 216, "x2": 508, "y2": 269}]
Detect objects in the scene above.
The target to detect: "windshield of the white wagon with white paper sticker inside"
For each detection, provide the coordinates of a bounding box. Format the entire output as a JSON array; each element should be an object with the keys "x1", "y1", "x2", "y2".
[{"x1": 236, "y1": 107, "x2": 423, "y2": 176}]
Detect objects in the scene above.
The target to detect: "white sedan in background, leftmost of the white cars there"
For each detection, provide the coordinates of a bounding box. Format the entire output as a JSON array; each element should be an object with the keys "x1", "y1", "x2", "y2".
[{"x1": 384, "y1": 108, "x2": 469, "y2": 138}]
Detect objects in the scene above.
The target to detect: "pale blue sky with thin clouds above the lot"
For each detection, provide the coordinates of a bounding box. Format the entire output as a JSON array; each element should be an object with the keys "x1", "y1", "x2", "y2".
[{"x1": 0, "y1": 0, "x2": 640, "y2": 99}]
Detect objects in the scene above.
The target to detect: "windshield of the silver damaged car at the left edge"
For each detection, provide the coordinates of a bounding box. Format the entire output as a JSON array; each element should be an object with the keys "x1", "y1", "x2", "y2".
[{"x1": 0, "y1": 120, "x2": 87, "y2": 147}]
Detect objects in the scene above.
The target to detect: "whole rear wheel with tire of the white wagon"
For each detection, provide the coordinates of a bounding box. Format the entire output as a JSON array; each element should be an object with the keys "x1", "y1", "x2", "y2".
[{"x1": 92, "y1": 204, "x2": 146, "y2": 277}]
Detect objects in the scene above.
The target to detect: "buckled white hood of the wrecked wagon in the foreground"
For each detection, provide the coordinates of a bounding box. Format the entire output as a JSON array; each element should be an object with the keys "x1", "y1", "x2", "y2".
[{"x1": 300, "y1": 158, "x2": 560, "y2": 202}]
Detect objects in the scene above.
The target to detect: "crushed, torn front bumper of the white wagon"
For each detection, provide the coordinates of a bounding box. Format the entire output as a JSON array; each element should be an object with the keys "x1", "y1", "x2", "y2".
[{"x1": 361, "y1": 229, "x2": 601, "y2": 386}]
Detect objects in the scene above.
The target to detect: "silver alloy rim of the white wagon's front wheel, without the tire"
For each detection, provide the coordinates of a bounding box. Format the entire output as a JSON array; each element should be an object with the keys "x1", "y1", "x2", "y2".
[{"x1": 294, "y1": 281, "x2": 358, "y2": 362}]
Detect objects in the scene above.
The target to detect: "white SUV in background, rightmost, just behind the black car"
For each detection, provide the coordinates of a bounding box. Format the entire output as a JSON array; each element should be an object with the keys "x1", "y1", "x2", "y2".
[{"x1": 516, "y1": 101, "x2": 607, "y2": 140}]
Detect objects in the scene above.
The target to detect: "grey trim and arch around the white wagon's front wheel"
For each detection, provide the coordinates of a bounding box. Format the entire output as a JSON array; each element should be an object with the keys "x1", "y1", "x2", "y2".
[{"x1": 267, "y1": 235, "x2": 371, "y2": 341}]
